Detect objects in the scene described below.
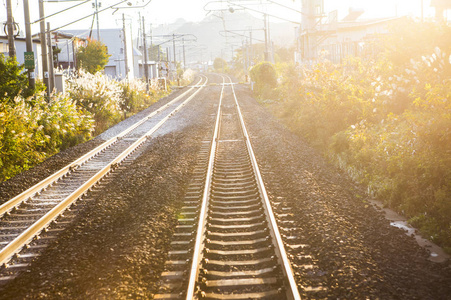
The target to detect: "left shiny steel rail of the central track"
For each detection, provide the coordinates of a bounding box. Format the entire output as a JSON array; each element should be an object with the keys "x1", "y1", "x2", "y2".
[{"x1": 186, "y1": 76, "x2": 225, "y2": 300}]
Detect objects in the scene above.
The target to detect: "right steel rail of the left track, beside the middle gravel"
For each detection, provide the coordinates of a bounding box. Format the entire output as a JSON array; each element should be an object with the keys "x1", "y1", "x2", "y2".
[{"x1": 0, "y1": 78, "x2": 208, "y2": 266}]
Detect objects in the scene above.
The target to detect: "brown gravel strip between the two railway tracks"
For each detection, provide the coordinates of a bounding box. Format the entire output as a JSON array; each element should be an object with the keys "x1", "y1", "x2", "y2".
[{"x1": 0, "y1": 78, "x2": 219, "y2": 299}]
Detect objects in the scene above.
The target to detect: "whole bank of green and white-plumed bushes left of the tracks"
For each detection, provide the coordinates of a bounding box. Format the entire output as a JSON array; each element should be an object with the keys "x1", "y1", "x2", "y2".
[{"x1": 0, "y1": 64, "x2": 171, "y2": 181}]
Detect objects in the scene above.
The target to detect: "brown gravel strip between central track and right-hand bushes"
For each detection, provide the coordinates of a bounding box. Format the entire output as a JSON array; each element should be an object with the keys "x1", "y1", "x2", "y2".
[{"x1": 238, "y1": 86, "x2": 451, "y2": 299}]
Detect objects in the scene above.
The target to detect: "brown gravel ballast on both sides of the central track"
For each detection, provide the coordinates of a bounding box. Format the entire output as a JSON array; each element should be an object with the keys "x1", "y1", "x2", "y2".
[{"x1": 0, "y1": 75, "x2": 451, "y2": 299}]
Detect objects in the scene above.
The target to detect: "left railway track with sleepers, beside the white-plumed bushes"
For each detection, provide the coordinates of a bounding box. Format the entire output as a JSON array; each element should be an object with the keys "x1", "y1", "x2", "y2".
[{"x1": 0, "y1": 76, "x2": 208, "y2": 283}]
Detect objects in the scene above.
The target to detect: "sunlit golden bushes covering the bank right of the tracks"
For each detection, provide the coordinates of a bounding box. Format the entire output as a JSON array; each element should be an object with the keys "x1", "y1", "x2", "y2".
[{"x1": 275, "y1": 21, "x2": 451, "y2": 251}]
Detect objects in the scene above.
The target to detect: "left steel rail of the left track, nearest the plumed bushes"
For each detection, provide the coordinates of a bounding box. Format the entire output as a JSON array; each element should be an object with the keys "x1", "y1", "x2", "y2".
[{"x1": 0, "y1": 75, "x2": 208, "y2": 217}]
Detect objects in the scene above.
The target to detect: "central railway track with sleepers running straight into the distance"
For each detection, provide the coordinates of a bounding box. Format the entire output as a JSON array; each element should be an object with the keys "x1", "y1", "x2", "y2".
[{"x1": 155, "y1": 77, "x2": 300, "y2": 299}]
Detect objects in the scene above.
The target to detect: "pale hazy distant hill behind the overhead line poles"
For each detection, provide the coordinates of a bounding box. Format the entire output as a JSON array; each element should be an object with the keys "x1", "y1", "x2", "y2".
[{"x1": 147, "y1": 12, "x2": 296, "y2": 62}]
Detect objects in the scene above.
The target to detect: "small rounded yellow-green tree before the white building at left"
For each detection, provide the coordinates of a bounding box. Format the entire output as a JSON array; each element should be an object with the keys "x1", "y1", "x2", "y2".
[{"x1": 77, "y1": 39, "x2": 111, "y2": 74}]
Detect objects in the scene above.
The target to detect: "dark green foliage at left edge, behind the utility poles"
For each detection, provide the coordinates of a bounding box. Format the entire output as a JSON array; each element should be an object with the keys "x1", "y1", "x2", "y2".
[{"x1": 0, "y1": 53, "x2": 33, "y2": 104}]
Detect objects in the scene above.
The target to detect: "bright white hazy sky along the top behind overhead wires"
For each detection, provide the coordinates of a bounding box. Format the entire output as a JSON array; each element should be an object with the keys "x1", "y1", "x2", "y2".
[{"x1": 0, "y1": 0, "x2": 434, "y2": 33}]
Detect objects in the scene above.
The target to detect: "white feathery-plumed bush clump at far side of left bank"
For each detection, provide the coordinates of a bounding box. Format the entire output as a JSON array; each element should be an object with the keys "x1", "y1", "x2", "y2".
[{"x1": 67, "y1": 70, "x2": 124, "y2": 134}]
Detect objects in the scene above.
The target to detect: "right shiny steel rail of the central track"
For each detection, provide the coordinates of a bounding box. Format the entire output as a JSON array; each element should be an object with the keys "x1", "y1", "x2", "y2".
[{"x1": 227, "y1": 76, "x2": 301, "y2": 300}]
